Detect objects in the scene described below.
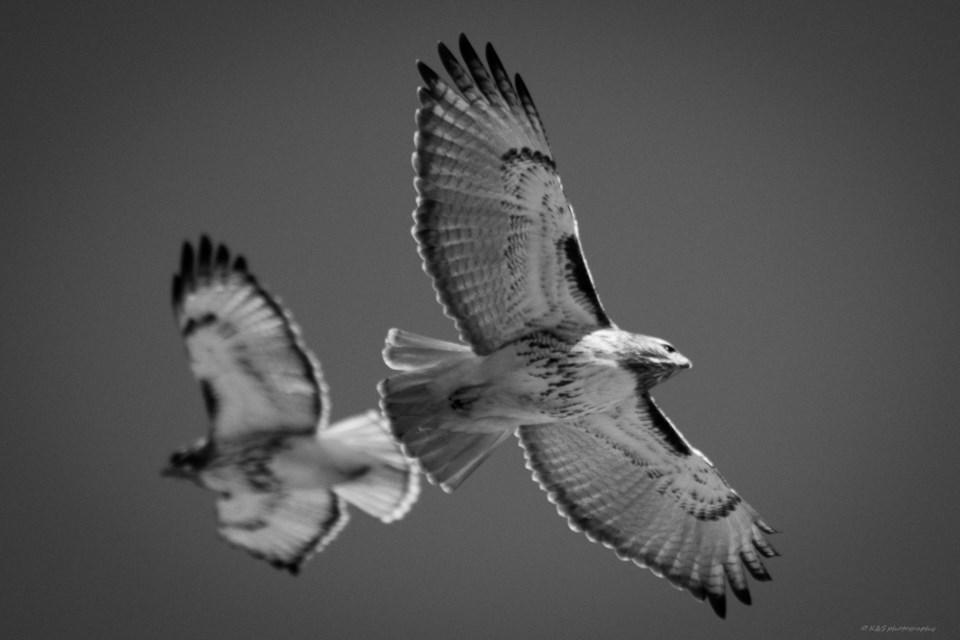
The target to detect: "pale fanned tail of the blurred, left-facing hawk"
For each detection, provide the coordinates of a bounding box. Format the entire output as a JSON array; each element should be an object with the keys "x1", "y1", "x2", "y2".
[{"x1": 322, "y1": 411, "x2": 420, "y2": 522}]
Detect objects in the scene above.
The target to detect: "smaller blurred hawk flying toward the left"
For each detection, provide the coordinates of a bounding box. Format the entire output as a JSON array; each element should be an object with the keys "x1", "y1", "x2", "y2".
[{"x1": 163, "y1": 236, "x2": 419, "y2": 574}]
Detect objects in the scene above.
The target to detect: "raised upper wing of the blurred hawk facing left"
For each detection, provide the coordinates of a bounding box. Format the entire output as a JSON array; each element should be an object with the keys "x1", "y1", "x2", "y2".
[{"x1": 173, "y1": 236, "x2": 329, "y2": 437}]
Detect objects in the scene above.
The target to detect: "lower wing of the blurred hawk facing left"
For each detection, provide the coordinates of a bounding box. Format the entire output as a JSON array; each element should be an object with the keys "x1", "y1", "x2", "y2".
[{"x1": 217, "y1": 489, "x2": 349, "y2": 574}]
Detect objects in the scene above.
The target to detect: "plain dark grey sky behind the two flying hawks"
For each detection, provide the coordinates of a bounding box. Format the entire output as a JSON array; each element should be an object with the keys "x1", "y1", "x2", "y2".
[{"x1": 0, "y1": 1, "x2": 960, "y2": 639}]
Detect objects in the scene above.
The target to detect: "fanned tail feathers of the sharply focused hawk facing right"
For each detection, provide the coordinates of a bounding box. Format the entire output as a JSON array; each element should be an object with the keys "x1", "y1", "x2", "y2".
[{"x1": 379, "y1": 329, "x2": 514, "y2": 492}]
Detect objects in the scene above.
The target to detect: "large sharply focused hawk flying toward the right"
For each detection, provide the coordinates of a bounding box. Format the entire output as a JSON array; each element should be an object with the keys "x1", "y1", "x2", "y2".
[{"x1": 379, "y1": 36, "x2": 776, "y2": 617}]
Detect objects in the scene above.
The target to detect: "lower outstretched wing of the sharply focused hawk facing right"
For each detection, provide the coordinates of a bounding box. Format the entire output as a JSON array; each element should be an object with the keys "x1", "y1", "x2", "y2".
[{"x1": 519, "y1": 394, "x2": 776, "y2": 617}]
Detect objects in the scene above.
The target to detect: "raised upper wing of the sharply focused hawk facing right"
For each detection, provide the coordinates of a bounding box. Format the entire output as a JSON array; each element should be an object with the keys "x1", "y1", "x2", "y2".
[{"x1": 413, "y1": 35, "x2": 611, "y2": 354}]
